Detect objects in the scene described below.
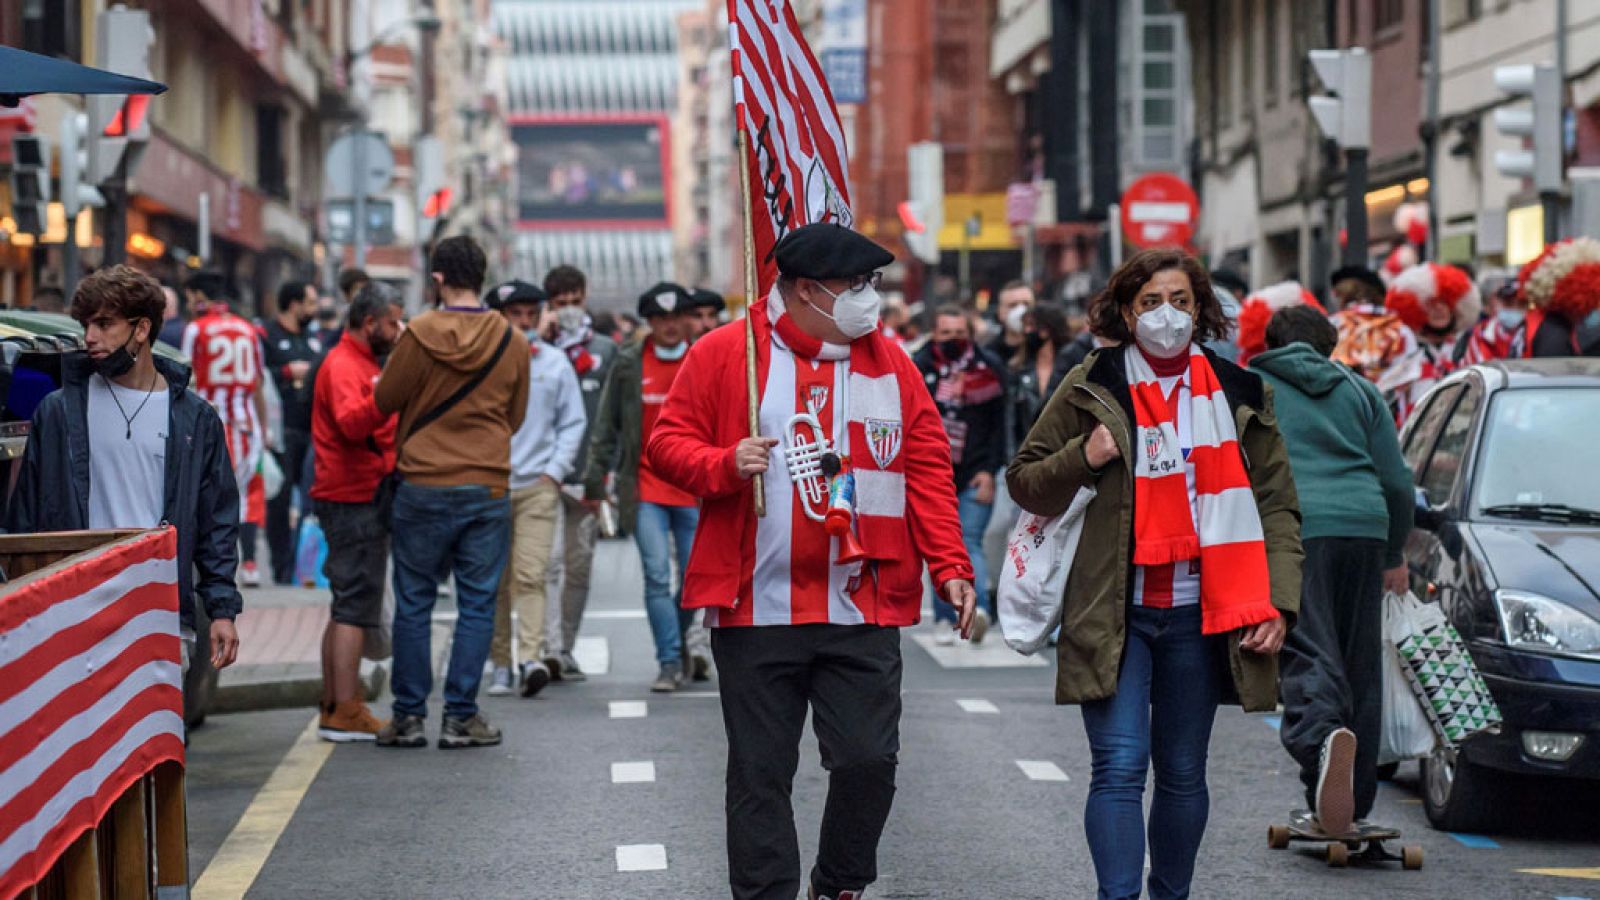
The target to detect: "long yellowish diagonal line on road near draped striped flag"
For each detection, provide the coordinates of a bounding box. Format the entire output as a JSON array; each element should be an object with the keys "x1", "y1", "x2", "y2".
[{"x1": 194, "y1": 716, "x2": 333, "y2": 900}]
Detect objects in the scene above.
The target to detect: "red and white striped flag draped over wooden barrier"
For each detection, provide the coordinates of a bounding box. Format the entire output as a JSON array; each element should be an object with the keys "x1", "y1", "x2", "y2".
[{"x1": 0, "y1": 528, "x2": 184, "y2": 897}]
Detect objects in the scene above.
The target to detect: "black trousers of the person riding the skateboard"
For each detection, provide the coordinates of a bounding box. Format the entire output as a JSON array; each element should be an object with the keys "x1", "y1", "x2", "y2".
[{"x1": 1278, "y1": 538, "x2": 1384, "y2": 818}]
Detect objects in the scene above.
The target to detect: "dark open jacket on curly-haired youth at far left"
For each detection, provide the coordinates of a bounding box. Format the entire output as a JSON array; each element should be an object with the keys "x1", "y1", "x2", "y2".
[{"x1": 6, "y1": 354, "x2": 243, "y2": 628}]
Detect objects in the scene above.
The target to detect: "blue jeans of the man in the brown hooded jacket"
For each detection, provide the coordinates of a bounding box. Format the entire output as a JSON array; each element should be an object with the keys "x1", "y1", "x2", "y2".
[{"x1": 390, "y1": 484, "x2": 510, "y2": 719}]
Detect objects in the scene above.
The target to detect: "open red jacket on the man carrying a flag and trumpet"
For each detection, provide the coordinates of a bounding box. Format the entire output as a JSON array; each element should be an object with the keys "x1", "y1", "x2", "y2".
[{"x1": 646, "y1": 299, "x2": 973, "y2": 626}]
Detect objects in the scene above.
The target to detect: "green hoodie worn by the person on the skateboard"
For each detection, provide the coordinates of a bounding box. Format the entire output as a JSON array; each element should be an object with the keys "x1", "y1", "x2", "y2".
[{"x1": 1250, "y1": 343, "x2": 1416, "y2": 569}]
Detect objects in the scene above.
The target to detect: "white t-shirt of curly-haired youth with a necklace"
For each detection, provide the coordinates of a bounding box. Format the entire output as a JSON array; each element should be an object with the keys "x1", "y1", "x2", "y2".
[{"x1": 90, "y1": 375, "x2": 171, "y2": 528}]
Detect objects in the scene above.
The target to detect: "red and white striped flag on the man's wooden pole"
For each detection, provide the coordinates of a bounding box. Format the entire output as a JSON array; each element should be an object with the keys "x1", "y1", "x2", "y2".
[{"x1": 728, "y1": 0, "x2": 854, "y2": 295}]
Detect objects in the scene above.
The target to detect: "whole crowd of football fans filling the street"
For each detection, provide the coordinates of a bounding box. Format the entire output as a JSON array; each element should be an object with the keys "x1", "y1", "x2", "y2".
[{"x1": 6, "y1": 224, "x2": 1600, "y2": 898}]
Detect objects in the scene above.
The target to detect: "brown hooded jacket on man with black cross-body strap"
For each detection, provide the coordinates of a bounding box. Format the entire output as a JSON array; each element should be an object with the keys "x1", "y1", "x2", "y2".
[{"x1": 376, "y1": 309, "x2": 528, "y2": 492}]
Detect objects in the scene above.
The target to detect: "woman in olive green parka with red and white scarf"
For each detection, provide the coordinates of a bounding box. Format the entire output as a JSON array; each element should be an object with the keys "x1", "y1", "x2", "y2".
[{"x1": 1006, "y1": 250, "x2": 1301, "y2": 898}]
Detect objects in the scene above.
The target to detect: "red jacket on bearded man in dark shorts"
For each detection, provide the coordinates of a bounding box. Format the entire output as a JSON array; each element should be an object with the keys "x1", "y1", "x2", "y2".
[{"x1": 310, "y1": 331, "x2": 395, "y2": 503}]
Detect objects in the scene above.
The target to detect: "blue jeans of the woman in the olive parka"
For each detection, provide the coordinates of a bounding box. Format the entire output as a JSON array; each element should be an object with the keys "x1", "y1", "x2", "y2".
[{"x1": 1083, "y1": 605, "x2": 1222, "y2": 900}]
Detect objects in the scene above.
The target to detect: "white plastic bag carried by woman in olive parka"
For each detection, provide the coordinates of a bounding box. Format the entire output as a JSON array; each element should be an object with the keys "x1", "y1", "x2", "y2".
[{"x1": 995, "y1": 487, "x2": 1094, "y2": 655}]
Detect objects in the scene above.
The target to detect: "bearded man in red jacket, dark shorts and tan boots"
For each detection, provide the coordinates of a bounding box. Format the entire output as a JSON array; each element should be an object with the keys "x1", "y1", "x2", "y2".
[{"x1": 310, "y1": 283, "x2": 400, "y2": 743}]
